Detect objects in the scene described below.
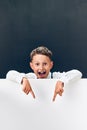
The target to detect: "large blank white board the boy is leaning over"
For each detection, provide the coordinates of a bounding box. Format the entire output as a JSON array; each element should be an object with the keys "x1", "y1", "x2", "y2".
[{"x1": 0, "y1": 79, "x2": 87, "y2": 130}]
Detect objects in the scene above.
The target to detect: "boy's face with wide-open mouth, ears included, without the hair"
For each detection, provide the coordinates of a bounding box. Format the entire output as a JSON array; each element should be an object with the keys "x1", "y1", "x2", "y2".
[{"x1": 30, "y1": 54, "x2": 53, "y2": 78}]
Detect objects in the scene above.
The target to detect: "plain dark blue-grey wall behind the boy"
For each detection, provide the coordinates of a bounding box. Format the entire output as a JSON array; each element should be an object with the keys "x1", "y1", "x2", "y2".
[{"x1": 0, "y1": 0, "x2": 87, "y2": 78}]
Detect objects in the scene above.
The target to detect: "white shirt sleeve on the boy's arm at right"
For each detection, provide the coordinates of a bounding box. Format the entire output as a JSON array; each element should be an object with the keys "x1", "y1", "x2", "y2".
[{"x1": 53, "y1": 70, "x2": 82, "y2": 84}]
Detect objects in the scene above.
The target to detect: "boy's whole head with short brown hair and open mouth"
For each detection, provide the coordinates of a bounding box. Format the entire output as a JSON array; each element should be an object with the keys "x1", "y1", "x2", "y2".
[{"x1": 30, "y1": 46, "x2": 53, "y2": 78}]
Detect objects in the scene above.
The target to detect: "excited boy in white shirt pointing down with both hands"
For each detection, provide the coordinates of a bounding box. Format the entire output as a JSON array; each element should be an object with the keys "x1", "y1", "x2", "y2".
[{"x1": 6, "y1": 46, "x2": 82, "y2": 101}]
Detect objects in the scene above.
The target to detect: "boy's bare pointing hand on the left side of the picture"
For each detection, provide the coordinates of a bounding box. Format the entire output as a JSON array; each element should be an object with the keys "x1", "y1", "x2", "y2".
[{"x1": 22, "y1": 78, "x2": 35, "y2": 98}]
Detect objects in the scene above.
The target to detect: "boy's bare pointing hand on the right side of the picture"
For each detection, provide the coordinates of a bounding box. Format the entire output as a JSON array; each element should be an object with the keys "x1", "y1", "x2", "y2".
[{"x1": 53, "y1": 81, "x2": 64, "y2": 101}]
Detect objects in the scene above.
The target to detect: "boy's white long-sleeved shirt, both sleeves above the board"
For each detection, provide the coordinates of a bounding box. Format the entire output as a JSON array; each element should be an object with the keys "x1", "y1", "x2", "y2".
[{"x1": 6, "y1": 69, "x2": 82, "y2": 84}]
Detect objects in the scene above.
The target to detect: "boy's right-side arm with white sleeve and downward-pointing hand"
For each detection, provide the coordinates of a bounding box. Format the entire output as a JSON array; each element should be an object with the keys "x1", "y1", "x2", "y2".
[{"x1": 53, "y1": 70, "x2": 82, "y2": 101}]
